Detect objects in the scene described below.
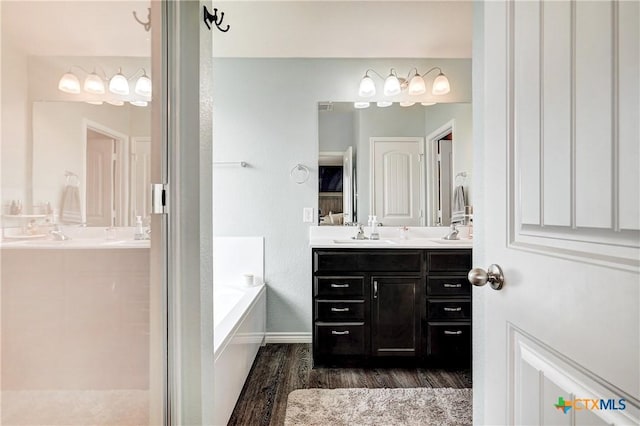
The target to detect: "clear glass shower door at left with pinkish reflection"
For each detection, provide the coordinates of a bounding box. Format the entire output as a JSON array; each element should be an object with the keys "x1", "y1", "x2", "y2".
[{"x1": 0, "y1": 1, "x2": 166, "y2": 425}]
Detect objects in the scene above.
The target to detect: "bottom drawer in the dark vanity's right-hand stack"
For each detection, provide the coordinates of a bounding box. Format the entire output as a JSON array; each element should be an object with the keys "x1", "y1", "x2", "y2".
[{"x1": 427, "y1": 322, "x2": 471, "y2": 360}]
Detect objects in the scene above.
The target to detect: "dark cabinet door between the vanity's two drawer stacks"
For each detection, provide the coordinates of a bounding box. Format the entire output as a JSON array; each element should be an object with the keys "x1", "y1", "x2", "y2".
[{"x1": 371, "y1": 276, "x2": 422, "y2": 357}]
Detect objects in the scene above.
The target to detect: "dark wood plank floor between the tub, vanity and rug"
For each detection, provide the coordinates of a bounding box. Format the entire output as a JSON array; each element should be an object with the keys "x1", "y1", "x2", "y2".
[{"x1": 229, "y1": 344, "x2": 471, "y2": 426}]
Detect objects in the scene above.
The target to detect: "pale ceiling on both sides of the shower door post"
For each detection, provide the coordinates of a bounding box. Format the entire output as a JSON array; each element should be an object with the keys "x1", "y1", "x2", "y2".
[{"x1": 1, "y1": 0, "x2": 473, "y2": 58}]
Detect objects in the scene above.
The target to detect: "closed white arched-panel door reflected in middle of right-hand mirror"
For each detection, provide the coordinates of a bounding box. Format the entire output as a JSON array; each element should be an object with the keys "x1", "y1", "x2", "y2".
[{"x1": 370, "y1": 137, "x2": 425, "y2": 226}]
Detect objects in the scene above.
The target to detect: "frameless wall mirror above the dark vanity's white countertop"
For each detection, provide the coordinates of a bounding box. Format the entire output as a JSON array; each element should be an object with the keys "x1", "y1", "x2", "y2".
[{"x1": 318, "y1": 102, "x2": 473, "y2": 226}]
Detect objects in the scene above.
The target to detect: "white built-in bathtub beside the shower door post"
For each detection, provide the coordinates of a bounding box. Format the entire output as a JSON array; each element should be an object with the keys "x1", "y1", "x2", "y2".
[{"x1": 213, "y1": 285, "x2": 267, "y2": 425}]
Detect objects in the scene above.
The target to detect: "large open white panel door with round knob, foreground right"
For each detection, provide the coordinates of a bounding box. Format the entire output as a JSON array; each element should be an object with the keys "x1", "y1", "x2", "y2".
[{"x1": 473, "y1": 1, "x2": 640, "y2": 425}]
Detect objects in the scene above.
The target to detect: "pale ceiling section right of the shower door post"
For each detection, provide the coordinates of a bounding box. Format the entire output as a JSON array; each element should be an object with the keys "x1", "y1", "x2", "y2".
[{"x1": 213, "y1": 0, "x2": 473, "y2": 58}]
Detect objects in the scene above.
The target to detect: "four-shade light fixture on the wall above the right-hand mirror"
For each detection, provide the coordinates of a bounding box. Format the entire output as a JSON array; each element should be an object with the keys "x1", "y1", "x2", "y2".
[{"x1": 358, "y1": 67, "x2": 451, "y2": 98}]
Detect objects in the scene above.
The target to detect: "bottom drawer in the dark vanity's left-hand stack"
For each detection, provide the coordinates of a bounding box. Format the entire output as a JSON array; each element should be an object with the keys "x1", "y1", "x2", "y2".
[{"x1": 313, "y1": 322, "x2": 365, "y2": 356}]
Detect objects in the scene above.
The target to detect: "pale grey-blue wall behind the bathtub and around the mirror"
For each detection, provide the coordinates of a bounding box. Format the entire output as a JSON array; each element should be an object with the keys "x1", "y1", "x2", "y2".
[{"x1": 213, "y1": 58, "x2": 471, "y2": 332}]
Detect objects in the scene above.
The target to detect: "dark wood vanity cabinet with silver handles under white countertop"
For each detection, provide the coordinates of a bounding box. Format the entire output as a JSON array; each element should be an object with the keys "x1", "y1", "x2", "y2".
[{"x1": 313, "y1": 248, "x2": 471, "y2": 367}]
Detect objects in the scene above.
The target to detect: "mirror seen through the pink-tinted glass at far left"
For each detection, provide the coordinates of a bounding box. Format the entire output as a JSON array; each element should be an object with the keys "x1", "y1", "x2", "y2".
[{"x1": 32, "y1": 101, "x2": 151, "y2": 226}]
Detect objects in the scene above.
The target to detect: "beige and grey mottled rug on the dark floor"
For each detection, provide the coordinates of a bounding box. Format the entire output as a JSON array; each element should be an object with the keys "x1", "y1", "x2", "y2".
[{"x1": 284, "y1": 388, "x2": 472, "y2": 426}]
